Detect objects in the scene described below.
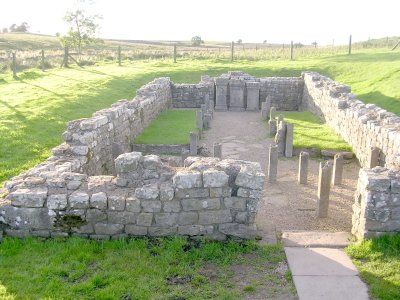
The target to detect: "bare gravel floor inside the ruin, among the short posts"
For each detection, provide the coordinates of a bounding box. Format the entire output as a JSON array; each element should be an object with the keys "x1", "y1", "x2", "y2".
[{"x1": 201, "y1": 111, "x2": 359, "y2": 234}]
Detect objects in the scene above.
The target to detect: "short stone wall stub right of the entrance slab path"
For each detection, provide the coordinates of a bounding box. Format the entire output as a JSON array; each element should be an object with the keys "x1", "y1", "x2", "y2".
[{"x1": 352, "y1": 167, "x2": 400, "y2": 238}]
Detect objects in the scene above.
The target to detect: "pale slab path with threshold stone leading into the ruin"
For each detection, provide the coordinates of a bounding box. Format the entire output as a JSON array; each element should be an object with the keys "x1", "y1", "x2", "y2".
[{"x1": 282, "y1": 231, "x2": 369, "y2": 300}]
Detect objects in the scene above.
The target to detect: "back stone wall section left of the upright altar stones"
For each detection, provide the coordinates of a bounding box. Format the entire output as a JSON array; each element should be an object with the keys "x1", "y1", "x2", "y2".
[{"x1": 171, "y1": 76, "x2": 214, "y2": 108}]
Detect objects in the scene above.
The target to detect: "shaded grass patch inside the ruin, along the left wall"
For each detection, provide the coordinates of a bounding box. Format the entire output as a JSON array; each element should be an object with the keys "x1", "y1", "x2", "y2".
[{"x1": 135, "y1": 109, "x2": 197, "y2": 144}]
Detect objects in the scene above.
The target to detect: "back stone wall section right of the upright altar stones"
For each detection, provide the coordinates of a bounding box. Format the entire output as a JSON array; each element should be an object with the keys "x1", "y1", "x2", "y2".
[{"x1": 260, "y1": 77, "x2": 304, "y2": 111}]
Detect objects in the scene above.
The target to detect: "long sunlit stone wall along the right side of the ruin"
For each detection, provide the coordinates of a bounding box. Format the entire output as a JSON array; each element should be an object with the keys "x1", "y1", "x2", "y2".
[{"x1": 302, "y1": 72, "x2": 400, "y2": 168}]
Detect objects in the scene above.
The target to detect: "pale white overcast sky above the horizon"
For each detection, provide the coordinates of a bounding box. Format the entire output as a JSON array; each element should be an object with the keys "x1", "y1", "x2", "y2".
[{"x1": 0, "y1": 0, "x2": 400, "y2": 45}]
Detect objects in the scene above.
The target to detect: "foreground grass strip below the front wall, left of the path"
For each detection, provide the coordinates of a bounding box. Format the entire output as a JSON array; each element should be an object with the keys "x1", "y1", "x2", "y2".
[{"x1": 0, "y1": 237, "x2": 293, "y2": 299}]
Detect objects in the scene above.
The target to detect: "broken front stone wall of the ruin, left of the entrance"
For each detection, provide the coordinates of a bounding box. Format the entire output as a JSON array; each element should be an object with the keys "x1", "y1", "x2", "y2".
[{"x1": 0, "y1": 152, "x2": 265, "y2": 239}]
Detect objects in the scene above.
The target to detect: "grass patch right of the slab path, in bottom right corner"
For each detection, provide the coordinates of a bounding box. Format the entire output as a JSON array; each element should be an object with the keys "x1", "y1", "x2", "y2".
[{"x1": 346, "y1": 234, "x2": 400, "y2": 300}]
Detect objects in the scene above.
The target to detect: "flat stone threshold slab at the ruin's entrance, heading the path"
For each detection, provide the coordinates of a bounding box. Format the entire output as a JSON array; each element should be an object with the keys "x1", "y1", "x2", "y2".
[{"x1": 282, "y1": 230, "x2": 350, "y2": 248}]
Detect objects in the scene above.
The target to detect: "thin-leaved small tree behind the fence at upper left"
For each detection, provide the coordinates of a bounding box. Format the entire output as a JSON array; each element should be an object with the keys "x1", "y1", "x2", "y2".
[{"x1": 60, "y1": 9, "x2": 102, "y2": 54}]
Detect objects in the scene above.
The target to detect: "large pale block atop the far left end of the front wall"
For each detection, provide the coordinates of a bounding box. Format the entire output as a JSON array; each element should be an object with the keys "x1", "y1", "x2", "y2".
[{"x1": 8, "y1": 188, "x2": 47, "y2": 207}]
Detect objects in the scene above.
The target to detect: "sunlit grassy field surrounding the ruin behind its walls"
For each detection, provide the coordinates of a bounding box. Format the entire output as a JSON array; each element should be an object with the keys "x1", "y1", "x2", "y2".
[{"x1": 0, "y1": 46, "x2": 400, "y2": 184}]
